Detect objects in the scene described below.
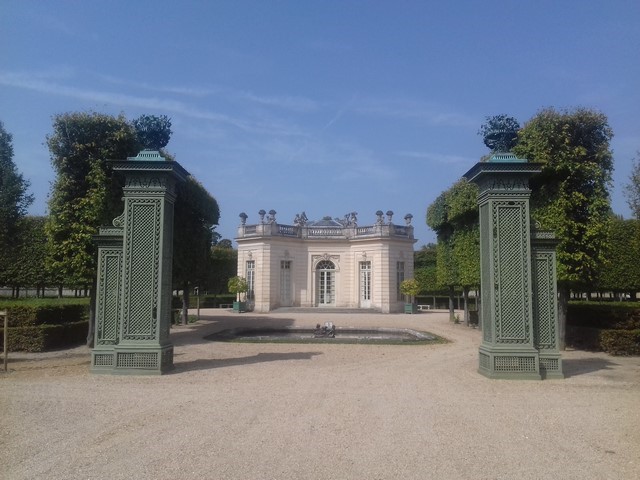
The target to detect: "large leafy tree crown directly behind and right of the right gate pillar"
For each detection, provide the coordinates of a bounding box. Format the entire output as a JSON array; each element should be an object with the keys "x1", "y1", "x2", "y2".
[{"x1": 513, "y1": 108, "x2": 613, "y2": 285}]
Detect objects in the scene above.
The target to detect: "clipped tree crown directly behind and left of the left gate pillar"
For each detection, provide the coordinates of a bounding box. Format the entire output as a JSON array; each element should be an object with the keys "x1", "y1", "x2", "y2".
[{"x1": 46, "y1": 113, "x2": 137, "y2": 286}]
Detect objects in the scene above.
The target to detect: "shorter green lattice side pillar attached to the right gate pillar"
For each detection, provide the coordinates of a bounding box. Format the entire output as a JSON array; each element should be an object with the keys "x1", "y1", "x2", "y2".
[{"x1": 531, "y1": 230, "x2": 564, "y2": 378}]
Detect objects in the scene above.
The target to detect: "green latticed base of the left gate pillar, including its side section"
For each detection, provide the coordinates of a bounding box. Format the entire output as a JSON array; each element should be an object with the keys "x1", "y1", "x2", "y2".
[{"x1": 91, "y1": 344, "x2": 174, "y2": 375}]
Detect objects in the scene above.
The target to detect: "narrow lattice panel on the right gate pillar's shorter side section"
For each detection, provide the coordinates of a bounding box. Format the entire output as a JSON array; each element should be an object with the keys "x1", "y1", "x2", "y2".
[{"x1": 533, "y1": 252, "x2": 556, "y2": 349}]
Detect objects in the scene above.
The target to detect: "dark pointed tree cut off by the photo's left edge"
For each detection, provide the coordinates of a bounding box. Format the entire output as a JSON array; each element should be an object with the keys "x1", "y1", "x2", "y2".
[{"x1": 0, "y1": 122, "x2": 33, "y2": 285}]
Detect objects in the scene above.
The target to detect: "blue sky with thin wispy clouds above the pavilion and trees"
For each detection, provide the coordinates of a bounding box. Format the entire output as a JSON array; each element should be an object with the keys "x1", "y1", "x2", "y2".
[{"x1": 0, "y1": 0, "x2": 640, "y2": 247}]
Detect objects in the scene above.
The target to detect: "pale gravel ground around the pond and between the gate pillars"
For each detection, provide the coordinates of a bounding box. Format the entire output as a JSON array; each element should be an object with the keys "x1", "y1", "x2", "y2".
[{"x1": 0, "y1": 310, "x2": 640, "y2": 480}]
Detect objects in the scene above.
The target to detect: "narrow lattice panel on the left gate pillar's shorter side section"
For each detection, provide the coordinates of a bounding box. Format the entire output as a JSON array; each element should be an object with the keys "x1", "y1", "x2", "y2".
[{"x1": 96, "y1": 249, "x2": 122, "y2": 345}]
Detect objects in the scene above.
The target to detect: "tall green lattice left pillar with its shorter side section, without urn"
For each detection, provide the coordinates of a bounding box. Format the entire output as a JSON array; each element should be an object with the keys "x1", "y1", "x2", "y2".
[{"x1": 92, "y1": 150, "x2": 188, "y2": 374}]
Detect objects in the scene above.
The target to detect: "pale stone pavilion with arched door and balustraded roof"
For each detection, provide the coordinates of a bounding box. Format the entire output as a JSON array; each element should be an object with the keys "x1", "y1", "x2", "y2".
[{"x1": 236, "y1": 210, "x2": 416, "y2": 313}]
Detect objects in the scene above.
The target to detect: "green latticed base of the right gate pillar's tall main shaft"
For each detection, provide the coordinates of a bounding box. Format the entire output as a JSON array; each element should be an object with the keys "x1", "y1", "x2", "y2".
[{"x1": 478, "y1": 345, "x2": 542, "y2": 380}]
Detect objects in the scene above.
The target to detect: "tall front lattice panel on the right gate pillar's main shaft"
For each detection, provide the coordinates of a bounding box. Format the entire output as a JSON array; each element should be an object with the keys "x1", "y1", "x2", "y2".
[{"x1": 493, "y1": 201, "x2": 530, "y2": 343}]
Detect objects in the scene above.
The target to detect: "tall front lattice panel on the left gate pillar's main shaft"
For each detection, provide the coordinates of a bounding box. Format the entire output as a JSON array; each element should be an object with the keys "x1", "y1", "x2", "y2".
[{"x1": 123, "y1": 199, "x2": 162, "y2": 340}]
